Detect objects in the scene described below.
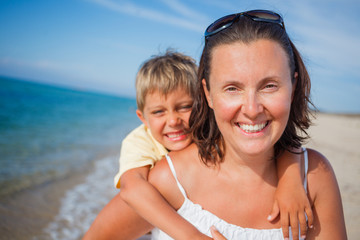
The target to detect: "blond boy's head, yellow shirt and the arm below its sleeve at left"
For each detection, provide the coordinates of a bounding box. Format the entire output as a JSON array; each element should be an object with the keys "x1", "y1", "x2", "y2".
[{"x1": 114, "y1": 52, "x2": 200, "y2": 239}]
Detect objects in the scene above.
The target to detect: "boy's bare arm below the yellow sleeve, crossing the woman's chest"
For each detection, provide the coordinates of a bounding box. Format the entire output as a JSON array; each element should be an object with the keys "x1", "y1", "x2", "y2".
[{"x1": 120, "y1": 166, "x2": 211, "y2": 239}]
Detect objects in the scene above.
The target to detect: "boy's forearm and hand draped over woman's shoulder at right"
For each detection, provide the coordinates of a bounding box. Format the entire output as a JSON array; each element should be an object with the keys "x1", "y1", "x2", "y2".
[{"x1": 268, "y1": 150, "x2": 313, "y2": 239}]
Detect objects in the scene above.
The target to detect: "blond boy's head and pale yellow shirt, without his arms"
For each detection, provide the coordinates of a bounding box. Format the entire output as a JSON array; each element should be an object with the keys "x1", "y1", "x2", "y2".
[{"x1": 114, "y1": 52, "x2": 197, "y2": 191}]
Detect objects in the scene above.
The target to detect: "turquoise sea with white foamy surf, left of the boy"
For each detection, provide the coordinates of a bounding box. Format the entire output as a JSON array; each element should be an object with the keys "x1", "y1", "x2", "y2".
[{"x1": 0, "y1": 77, "x2": 140, "y2": 239}]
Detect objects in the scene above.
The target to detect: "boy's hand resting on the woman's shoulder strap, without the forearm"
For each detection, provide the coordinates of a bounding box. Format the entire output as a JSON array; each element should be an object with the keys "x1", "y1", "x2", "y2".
[{"x1": 268, "y1": 184, "x2": 313, "y2": 240}]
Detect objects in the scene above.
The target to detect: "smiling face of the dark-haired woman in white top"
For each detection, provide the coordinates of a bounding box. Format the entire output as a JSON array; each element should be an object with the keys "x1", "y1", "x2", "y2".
[{"x1": 203, "y1": 40, "x2": 295, "y2": 156}]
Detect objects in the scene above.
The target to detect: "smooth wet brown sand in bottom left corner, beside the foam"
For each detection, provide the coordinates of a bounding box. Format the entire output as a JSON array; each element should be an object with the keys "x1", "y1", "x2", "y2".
[{"x1": 0, "y1": 171, "x2": 88, "y2": 240}]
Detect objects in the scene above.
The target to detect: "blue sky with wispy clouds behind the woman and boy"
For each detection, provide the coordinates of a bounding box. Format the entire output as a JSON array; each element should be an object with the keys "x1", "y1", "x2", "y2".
[{"x1": 0, "y1": 0, "x2": 360, "y2": 113}]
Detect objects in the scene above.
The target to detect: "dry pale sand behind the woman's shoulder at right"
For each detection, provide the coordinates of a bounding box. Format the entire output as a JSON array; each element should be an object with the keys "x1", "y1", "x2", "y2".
[{"x1": 306, "y1": 114, "x2": 360, "y2": 239}]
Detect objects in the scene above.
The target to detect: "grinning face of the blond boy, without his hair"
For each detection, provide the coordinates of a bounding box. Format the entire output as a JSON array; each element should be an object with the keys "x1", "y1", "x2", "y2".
[{"x1": 136, "y1": 88, "x2": 193, "y2": 151}]
